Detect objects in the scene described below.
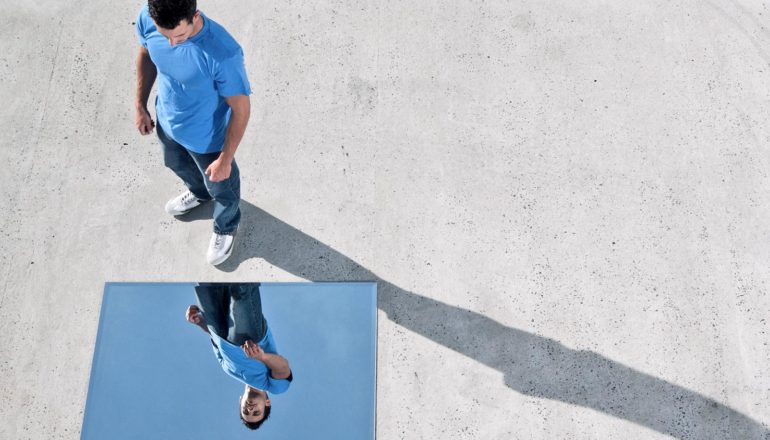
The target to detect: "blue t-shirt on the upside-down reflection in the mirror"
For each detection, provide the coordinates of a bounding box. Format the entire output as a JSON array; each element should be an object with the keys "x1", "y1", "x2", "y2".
[{"x1": 209, "y1": 327, "x2": 292, "y2": 394}]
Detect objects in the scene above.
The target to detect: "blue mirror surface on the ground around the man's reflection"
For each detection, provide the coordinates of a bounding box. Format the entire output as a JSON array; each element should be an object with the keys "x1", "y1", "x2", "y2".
[{"x1": 81, "y1": 283, "x2": 377, "y2": 440}]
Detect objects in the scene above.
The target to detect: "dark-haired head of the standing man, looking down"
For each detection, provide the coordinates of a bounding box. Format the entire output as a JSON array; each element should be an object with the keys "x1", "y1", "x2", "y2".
[{"x1": 147, "y1": 0, "x2": 201, "y2": 46}]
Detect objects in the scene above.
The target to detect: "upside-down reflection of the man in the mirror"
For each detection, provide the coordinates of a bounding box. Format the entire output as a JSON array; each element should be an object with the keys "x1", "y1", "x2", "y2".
[{"x1": 186, "y1": 283, "x2": 292, "y2": 429}]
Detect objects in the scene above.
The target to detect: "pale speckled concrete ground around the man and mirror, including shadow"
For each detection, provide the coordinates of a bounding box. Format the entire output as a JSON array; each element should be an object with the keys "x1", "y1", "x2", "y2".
[{"x1": 0, "y1": 0, "x2": 770, "y2": 440}]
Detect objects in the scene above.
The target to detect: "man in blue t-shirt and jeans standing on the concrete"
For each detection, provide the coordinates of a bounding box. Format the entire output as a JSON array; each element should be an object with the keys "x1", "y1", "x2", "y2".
[{"x1": 136, "y1": 0, "x2": 251, "y2": 265}]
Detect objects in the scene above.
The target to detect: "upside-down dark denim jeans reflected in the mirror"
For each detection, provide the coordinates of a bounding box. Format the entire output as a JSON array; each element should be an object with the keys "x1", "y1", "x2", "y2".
[{"x1": 195, "y1": 283, "x2": 267, "y2": 345}]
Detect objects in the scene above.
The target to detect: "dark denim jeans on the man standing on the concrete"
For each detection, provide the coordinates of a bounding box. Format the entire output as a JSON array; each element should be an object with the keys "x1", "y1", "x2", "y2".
[{"x1": 156, "y1": 124, "x2": 241, "y2": 234}]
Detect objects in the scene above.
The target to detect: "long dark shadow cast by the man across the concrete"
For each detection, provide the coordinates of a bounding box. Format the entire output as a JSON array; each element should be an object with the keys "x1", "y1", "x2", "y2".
[{"x1": 198, "y1": 201, "x2": 770, "y2": 440}]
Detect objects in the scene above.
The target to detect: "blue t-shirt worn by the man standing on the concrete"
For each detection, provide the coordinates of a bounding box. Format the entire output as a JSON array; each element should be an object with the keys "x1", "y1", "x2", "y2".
[{"x1": 136, "y1": 6, "x2": 251, "y2": 153}]
